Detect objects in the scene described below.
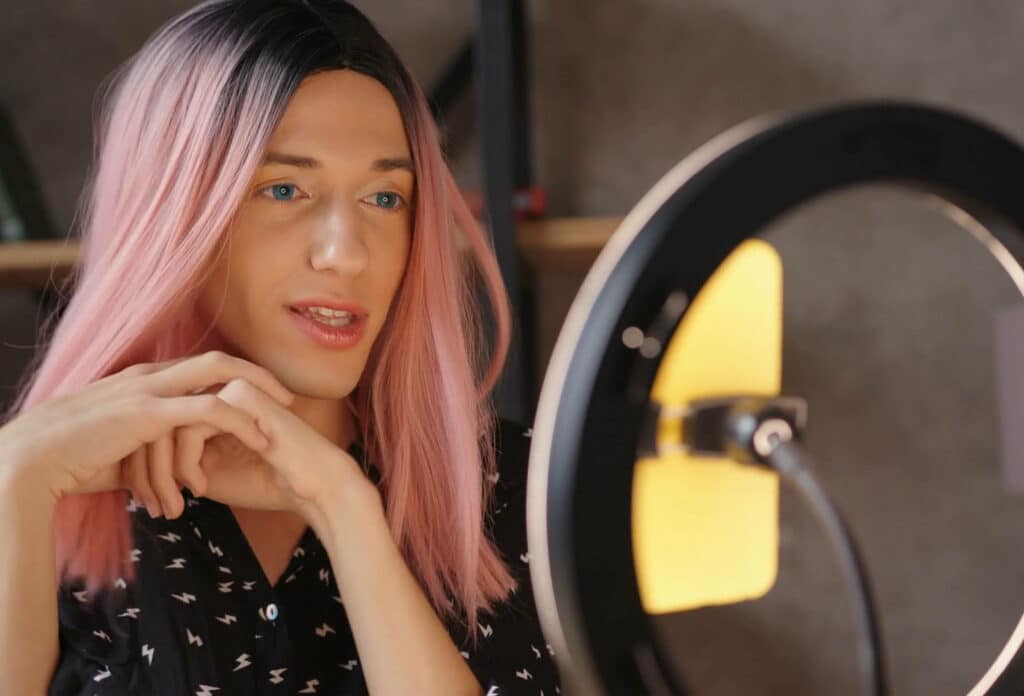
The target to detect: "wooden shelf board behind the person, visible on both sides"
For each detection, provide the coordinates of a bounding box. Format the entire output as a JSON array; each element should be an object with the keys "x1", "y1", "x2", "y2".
[{"x1": 0, "y1": 217, "x2": 622, "y2": 290}]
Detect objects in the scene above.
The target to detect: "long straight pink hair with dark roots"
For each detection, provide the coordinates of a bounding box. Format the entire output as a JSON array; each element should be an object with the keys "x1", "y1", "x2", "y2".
[{"x1": 8, "y1": 0, "x2": 515, "y2": 637}]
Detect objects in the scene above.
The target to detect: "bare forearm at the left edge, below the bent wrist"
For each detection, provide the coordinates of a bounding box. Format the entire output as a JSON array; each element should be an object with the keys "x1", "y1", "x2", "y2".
[{"x1": 0, "y1": 459, "x2": 58, "y2": 694}]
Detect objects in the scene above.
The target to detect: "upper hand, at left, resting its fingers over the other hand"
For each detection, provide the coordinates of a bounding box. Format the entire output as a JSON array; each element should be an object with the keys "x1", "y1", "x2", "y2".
[{"x1": 0, "y1": 351, "x2": 294, "y2": 501}]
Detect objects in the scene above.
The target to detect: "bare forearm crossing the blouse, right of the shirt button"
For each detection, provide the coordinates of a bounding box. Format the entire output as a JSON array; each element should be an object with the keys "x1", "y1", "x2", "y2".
[{"x1": 315, "y1": 486, "x2": 482, "y2": 696}]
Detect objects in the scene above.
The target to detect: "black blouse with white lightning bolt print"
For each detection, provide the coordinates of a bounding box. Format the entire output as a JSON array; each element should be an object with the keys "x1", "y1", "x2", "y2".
[{"x1": 49, "y1": 421, "x2": 559, "y2": 696}]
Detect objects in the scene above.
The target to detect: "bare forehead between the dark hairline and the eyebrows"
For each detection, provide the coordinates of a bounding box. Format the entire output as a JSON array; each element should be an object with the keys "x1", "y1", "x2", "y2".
[{"x1": 267, "y1": 70, "x2": 409, "y2": 161}]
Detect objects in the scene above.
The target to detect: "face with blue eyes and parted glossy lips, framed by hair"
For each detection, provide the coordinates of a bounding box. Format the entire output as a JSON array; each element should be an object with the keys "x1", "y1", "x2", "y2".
[{"x1": 200, "y1": 70, "x2": 415, "y2": 399}]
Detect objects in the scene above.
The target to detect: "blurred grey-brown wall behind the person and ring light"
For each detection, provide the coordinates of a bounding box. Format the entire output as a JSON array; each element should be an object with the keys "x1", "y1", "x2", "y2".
[{"x1": 0, "y1": 0, "x2": 1024, "y2": 694}]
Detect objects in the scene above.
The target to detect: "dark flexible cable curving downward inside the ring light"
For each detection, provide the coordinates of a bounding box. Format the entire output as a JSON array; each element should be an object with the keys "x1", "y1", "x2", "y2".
[{"x1": 765, "y1": 435, "x2": 889, "y2": 696}]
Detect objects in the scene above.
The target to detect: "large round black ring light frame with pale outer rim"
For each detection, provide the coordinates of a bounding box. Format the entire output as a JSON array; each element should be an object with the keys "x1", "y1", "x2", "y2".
[{"x1": 527, "y1": 102, "x2": 1024, "y2": 695}]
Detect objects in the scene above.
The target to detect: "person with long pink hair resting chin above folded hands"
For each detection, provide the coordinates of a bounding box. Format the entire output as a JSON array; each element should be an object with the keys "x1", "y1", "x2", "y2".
[{"x1": 0, "y1": 0, "x2": 560, "y2": 696}]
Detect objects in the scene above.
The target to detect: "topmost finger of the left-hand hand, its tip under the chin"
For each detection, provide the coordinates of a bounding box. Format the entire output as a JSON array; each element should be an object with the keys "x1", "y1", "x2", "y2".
[{"x1": 150, "y1": 350, "x2": 295, "y2": 406}]
